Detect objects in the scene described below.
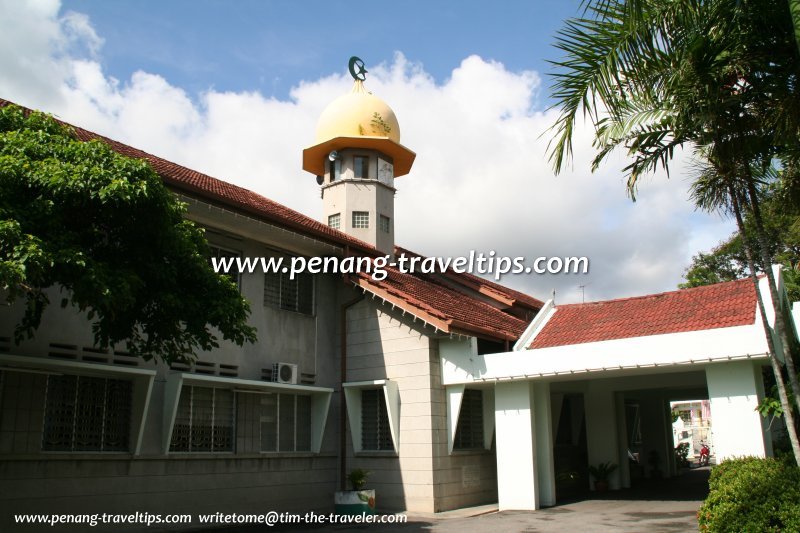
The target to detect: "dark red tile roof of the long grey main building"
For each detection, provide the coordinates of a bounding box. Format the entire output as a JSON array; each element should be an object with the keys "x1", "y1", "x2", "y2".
[{"x1": 0, "y1": 98, "x2": 542, "y2": 340}]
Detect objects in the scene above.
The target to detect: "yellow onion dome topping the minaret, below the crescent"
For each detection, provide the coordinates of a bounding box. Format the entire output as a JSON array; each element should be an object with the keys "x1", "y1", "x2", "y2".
[{"x1": 317, "y1": 80, "x2": 400, "y2": 143}]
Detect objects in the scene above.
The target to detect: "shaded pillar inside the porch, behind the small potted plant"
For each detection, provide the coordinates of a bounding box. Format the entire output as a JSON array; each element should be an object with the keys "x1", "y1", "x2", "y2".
[{"x1": 583, "y1": 382, "x2": 620, "y2": 489}]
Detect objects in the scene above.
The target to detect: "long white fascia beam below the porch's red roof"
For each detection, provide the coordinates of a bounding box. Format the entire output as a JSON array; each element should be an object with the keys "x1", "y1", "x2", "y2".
[{"x1": 442, "y1": 321, "x2": 767, "y2": 385}]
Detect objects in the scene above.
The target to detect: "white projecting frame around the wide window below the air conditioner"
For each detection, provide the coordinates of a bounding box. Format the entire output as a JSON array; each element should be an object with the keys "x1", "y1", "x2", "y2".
[{"x1": 163, "y1": 372, "x2": 333, "y2": 454}]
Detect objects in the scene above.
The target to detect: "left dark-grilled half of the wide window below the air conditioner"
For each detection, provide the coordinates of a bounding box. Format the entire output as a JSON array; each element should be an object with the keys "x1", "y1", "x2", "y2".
[{"x1": 169, "y1": 385, "x2": 234, "y2": 452}]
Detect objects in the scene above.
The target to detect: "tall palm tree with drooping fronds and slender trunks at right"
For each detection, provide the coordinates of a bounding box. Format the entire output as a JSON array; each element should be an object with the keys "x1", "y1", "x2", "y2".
[{"x1": 550, "y1": 0, "x2": 800, "y2": 464}]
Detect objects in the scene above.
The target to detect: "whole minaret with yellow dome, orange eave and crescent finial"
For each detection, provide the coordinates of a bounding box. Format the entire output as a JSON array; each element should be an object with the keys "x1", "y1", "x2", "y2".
[{"x1": 303, "y1": 57, "x2": 416, "y2": 254}]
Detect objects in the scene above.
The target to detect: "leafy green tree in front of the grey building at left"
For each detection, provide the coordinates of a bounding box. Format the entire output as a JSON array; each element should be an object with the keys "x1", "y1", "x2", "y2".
[{"x1": 0, "y1": 106, "x2": 255, "y2": 362}]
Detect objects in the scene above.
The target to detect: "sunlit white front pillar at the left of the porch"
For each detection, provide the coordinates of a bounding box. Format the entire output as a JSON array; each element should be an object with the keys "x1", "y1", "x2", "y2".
[{"x1": 494, "y1": 381, "x2": 539, "y2": 511}]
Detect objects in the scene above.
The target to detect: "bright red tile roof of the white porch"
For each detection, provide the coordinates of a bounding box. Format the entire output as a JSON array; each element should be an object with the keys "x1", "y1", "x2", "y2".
[{"x1": 530, "y1": 278, "x2": 756, "y2": 349}]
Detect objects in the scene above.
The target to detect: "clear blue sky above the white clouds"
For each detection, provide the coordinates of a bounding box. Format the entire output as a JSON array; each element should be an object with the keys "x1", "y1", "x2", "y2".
[{"x1": 63, "y1": 0, "x2": 579, "y2": 103}]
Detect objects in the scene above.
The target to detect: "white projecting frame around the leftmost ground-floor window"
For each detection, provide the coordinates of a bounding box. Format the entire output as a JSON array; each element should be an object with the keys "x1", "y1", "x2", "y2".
[{"x1": 0, "y1": 354, "x2": 156, "y2": 455}]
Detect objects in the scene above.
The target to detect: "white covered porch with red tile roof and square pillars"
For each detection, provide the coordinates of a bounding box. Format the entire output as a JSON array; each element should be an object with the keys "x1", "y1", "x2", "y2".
[{"x1": 440, "y1": 272, "x2": 792, "y2": 510}]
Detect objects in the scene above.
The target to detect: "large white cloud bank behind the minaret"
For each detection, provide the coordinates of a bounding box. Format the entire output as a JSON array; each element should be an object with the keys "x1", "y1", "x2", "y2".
[{"x1": 0, "y1": 0, "x2": 730, "y2": 303}]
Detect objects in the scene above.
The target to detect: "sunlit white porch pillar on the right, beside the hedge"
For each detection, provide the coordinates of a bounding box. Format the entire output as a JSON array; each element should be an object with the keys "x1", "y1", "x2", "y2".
[{"x1": 706, "y1": 361, "x2": 767, "y2": 461}]
